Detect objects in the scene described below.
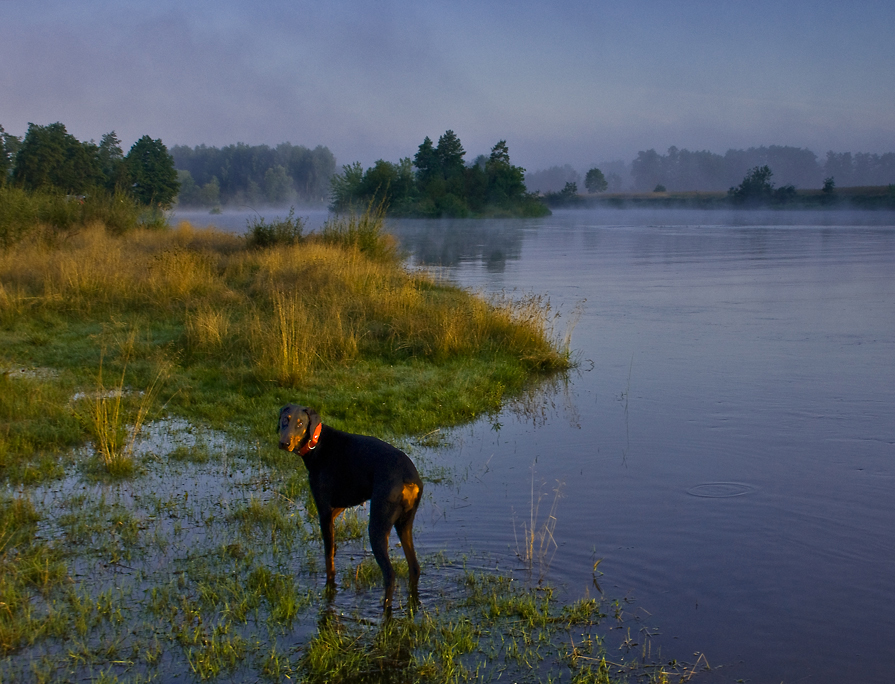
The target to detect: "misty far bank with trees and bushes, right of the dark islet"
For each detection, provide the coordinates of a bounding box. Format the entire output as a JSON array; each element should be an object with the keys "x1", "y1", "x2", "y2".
[{"x1": 525, "y1": 145, "x2": 895, "y2": 209}]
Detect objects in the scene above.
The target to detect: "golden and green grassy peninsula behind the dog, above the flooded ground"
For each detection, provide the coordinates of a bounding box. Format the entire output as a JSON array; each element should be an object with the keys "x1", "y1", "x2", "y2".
[{"x1": 0, "y1": 208, "x2": 569, "y2": 462}]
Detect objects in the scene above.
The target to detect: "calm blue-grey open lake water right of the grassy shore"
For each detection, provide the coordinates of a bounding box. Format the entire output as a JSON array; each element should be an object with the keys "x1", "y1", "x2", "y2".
[{"x1": 393, "y1": 211, "x2": 895, "y2": 682}]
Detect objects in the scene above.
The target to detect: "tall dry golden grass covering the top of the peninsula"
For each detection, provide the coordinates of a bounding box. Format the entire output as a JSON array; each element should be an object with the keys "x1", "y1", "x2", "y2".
[{"x1": 0, "y1": 216, "x2": 568, "y2": 385}]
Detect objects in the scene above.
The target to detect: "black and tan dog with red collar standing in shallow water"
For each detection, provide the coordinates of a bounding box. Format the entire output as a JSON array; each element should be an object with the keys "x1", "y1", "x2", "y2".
[{"x1": 278, "y1": 404, "x2": 423, "y2": 608}]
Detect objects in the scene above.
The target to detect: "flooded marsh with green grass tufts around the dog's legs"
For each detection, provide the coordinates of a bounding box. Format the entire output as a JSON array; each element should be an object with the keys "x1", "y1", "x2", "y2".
[{"x1": 0, "y1": 432, "x2": 680, "y2": 682}]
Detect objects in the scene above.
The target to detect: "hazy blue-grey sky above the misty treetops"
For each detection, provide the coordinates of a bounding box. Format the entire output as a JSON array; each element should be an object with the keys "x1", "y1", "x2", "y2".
[{"x1": 0, "y1": 0, "x2": 895, "y2": 171}]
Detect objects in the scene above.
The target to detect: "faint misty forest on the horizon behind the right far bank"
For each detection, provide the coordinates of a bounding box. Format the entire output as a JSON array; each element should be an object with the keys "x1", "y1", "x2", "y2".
[{"x1": 525, "y1": 145, "x2": 895, "y2": 193}]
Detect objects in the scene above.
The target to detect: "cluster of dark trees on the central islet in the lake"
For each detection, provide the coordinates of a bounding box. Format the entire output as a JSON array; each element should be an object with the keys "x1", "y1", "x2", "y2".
[{"x1": 330, "y1": 130, "x2": 549, "y2": 218}]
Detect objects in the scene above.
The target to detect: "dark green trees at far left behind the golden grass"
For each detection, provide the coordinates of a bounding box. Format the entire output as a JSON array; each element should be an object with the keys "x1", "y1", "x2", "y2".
[{"x1": 0, "y1": 122, "x2": 180, "y2": 209}]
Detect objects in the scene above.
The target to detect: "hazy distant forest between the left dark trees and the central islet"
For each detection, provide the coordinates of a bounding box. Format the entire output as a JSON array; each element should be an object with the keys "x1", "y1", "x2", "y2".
[{"x1": 171, "y1": 142, "x2": 336, "y2": 207}]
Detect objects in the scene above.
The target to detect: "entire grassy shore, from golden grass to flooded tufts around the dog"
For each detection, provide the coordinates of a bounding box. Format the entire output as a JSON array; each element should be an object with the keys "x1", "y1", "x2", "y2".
[{"x1": 0, "y1": 215, "x2": 686, "y2": 682}]
